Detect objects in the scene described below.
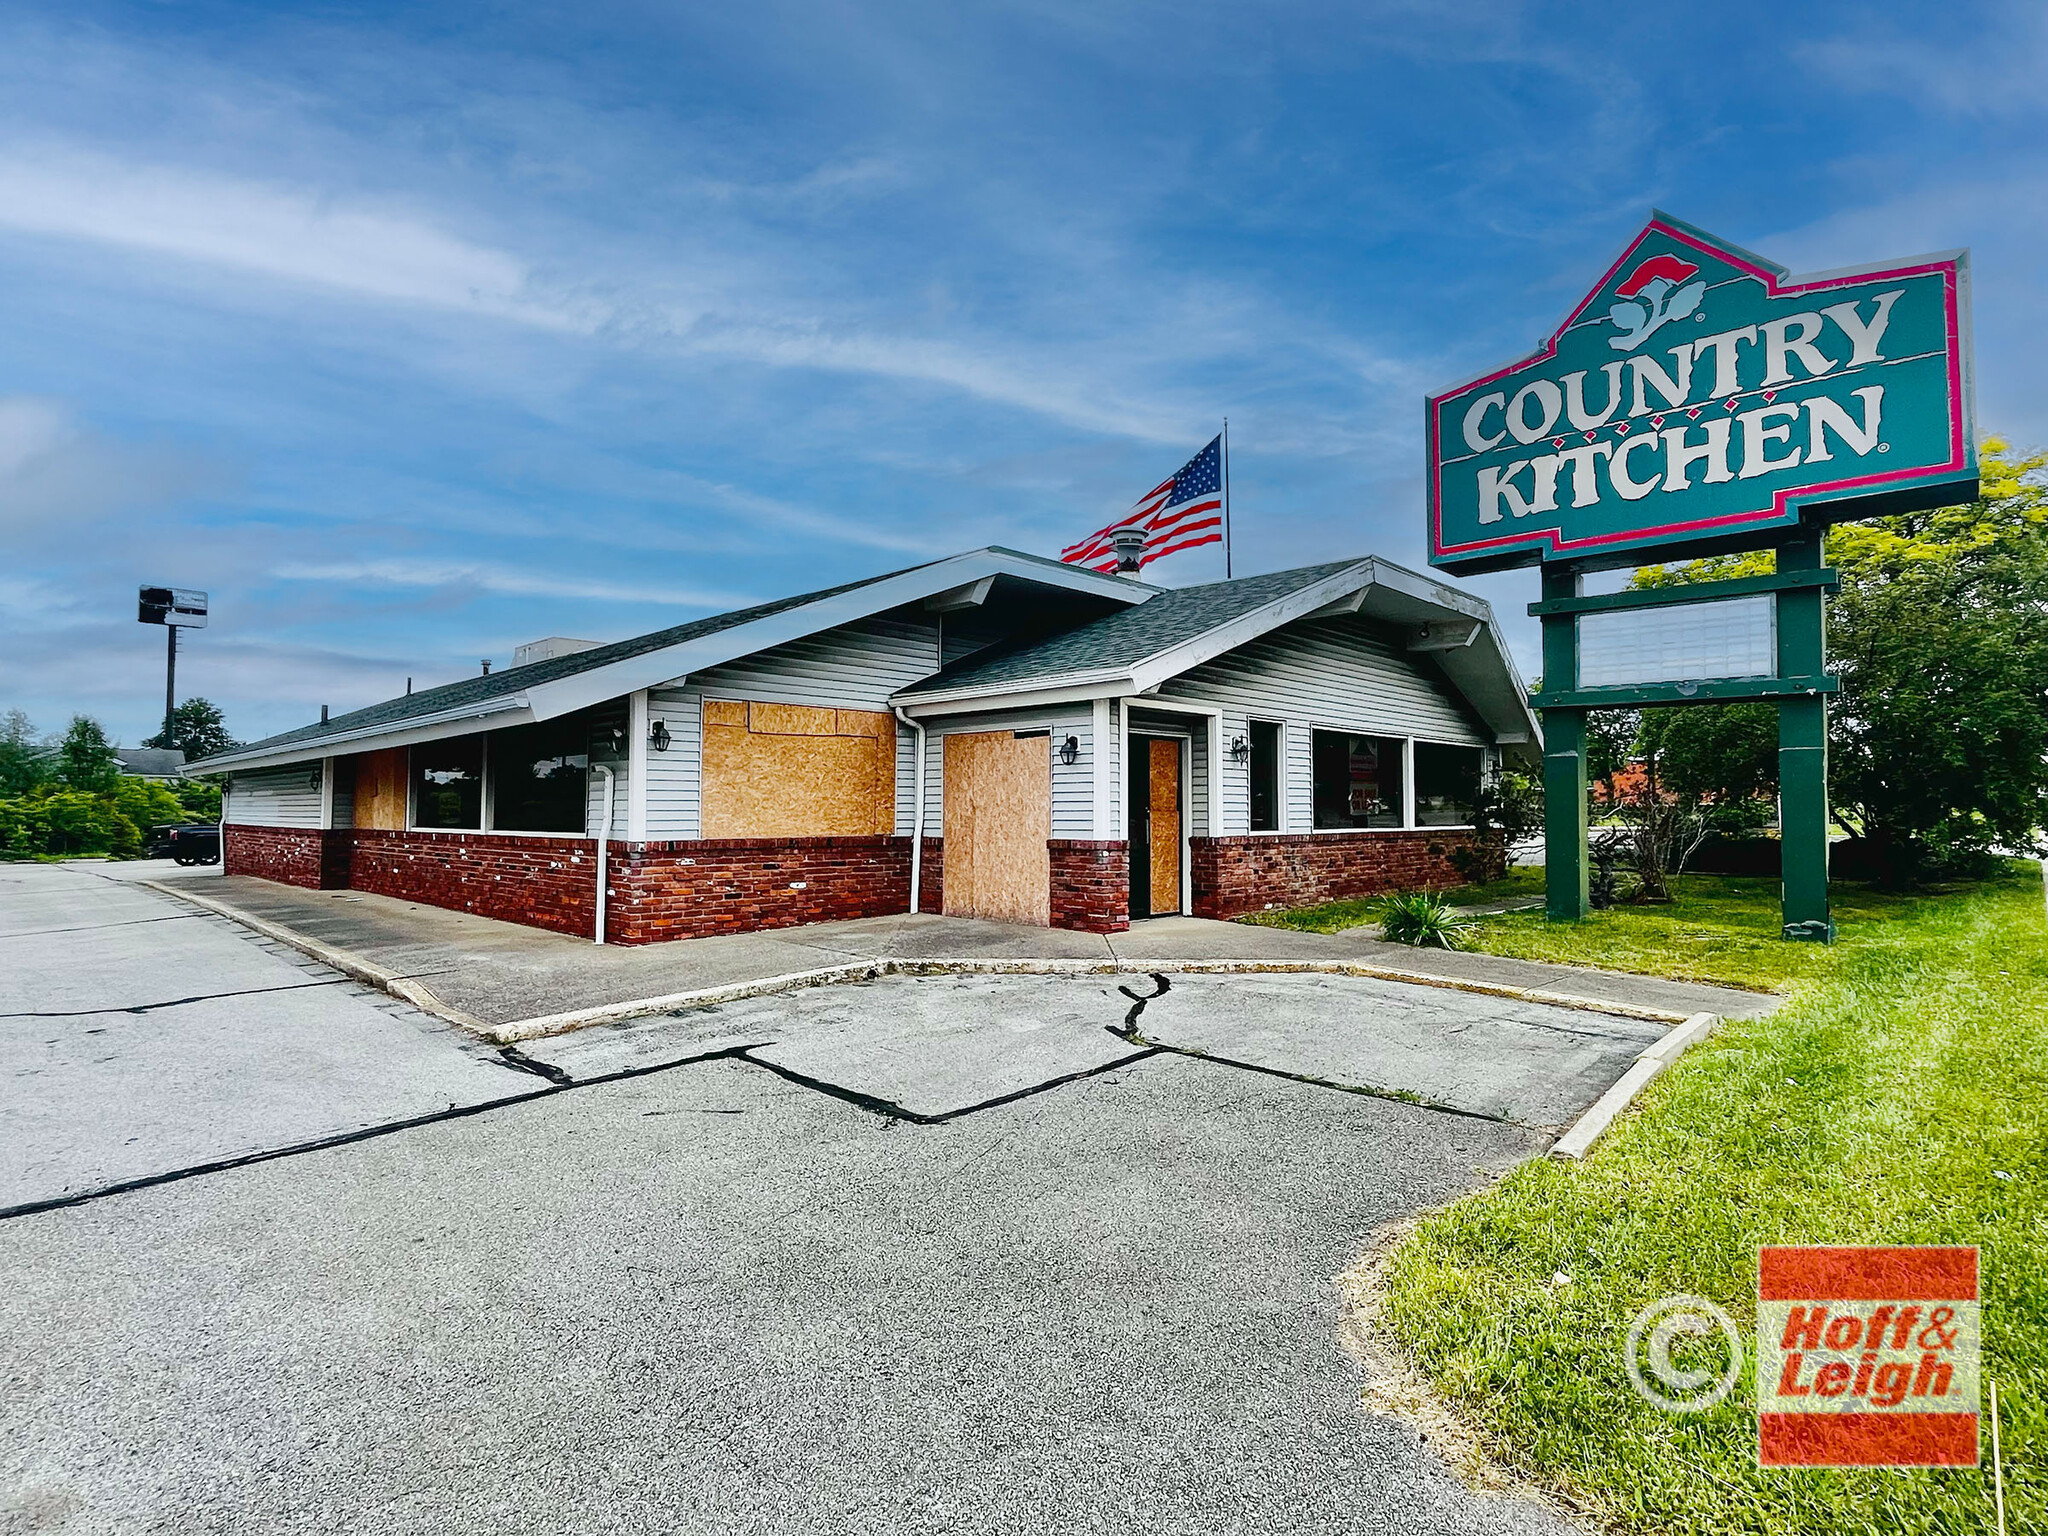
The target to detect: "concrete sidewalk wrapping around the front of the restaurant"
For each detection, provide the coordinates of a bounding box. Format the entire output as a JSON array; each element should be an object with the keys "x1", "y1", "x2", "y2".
[{"x1": 144, "y1": 874, "x2": 1778, "y2": 1026}]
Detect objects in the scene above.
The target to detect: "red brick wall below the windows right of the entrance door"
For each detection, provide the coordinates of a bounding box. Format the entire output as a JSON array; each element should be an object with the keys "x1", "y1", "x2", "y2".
[{"x1": 1188, "y1": 831, "x2": 1473, "y2": 918}]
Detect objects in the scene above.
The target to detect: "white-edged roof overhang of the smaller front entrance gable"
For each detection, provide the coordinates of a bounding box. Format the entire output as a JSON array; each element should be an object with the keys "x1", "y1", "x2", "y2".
[{"x1": 893, "y1": 557, "x2": 1542, "y2": 760}]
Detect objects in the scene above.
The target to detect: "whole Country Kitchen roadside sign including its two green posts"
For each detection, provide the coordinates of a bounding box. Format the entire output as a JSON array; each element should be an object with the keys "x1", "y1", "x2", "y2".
[{"x1": 1427, "y1": 213, "x2": 1976, "y2": 940}]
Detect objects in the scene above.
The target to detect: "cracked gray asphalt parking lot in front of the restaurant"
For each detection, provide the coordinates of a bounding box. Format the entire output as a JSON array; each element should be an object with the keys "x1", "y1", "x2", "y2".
[{"x1": 0, "y1": 868, "x2": 1597, "y2": 1532}]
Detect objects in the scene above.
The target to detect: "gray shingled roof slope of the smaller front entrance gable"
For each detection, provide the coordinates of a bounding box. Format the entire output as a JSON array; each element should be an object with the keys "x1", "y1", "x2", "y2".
[{"x1": 899, "y1": 557, "x2": 1364, "y2": 696}]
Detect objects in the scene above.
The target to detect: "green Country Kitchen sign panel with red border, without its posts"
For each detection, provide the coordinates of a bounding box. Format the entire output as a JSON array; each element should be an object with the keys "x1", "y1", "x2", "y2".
[{"x1": 1427, "y1": 213, "x2": 1976, "y2": 571}]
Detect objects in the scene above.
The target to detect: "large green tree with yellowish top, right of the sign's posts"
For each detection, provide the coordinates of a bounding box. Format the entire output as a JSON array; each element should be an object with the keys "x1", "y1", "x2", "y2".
[{"x1": 1636, "y1": 438, "x2": 2048, "y2": 883}]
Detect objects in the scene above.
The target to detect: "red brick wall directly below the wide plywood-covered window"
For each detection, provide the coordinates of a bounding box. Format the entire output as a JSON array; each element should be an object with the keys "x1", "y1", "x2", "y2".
[{"x1": 606, "y1": 838, "x2": 913, "y2": 944}]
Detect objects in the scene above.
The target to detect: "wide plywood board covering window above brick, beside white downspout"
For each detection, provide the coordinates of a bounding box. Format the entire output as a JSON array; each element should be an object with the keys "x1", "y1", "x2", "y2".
[{"x1": 702, "y1": 698, "x2": 895, "y2": 838}]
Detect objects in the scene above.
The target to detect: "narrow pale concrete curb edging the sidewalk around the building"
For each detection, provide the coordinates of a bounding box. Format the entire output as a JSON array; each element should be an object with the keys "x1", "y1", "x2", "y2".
[{"x1": 135, "y1": 881, "x2": 1706, "y2": 1048}]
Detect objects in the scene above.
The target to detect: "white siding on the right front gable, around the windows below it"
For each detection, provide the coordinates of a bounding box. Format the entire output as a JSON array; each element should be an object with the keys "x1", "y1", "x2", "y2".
[{"x1": 1159, "y1": 618, "x2": 1489, "y2": 836}]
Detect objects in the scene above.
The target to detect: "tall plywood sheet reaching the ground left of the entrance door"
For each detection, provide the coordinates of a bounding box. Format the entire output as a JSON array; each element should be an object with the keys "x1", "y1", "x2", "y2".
[{"x1": 944, "y1": 731, "x2": 1053, "y2": 928}]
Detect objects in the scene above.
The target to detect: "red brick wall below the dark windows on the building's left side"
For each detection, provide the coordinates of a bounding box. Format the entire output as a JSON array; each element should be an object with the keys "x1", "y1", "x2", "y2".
[{"x1": 350, "y1": 827, "x2": 598, "y2": 938}]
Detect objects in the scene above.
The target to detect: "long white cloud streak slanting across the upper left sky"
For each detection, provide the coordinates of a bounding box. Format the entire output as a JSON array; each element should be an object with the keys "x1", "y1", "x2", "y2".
[{"x1": 0, "y1": 141, "x2": 1278, "y2": 442}]
